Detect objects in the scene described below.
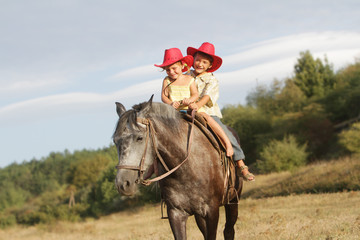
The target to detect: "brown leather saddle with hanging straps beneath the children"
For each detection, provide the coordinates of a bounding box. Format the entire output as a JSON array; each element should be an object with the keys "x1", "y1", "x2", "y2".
[{"x1": 182, "y1": 113, "x2": 239, "y2": 204}]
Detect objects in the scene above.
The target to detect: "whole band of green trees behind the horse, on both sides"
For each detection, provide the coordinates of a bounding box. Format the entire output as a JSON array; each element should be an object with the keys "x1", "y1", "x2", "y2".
[{"x1": 0, "y1": 51, "x2": 360, "y2": 227}]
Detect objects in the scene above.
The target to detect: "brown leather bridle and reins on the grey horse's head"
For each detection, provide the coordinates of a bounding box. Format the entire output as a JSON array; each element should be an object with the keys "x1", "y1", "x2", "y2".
[{"x1": 115, "y1": 110, "x2": 196, "y2": 186}]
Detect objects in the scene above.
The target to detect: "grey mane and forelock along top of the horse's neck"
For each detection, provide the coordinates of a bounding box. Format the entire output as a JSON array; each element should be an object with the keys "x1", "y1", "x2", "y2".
[{"x1": 112, "y1": 102, "x2": 181, "y2": 138}]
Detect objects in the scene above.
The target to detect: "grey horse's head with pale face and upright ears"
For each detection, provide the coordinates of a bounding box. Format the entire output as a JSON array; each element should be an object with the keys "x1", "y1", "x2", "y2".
[{"x1": 113, "y1": 97, "x2": 154, "y2": 196}]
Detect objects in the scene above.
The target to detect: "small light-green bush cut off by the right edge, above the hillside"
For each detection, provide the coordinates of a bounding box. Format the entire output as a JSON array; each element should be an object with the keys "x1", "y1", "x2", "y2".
[{"x1": 339, "y1": 122, "x2": 360, "y2": 153}]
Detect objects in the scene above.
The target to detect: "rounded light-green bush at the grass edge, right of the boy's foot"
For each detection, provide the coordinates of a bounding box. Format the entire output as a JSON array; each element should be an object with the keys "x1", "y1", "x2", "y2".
[{"x1": 257, "y1": 135, "x2": 308, "y2": 173}]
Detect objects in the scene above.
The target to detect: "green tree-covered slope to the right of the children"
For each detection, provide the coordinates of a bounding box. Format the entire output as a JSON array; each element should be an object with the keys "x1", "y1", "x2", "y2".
[{"x1": 222, "y1": 51, "x2": 360, "y2": 173}]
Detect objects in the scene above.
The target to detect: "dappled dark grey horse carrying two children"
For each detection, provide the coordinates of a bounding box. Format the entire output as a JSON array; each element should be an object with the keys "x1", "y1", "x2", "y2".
[{"x1": 113, "y1": 97, "x2": 242, "y2": 240}]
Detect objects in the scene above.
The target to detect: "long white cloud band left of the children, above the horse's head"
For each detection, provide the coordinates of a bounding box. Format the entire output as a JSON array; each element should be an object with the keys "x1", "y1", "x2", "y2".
[{"x1": 0, "y1": 79, "x2": 161, "y2": 125}]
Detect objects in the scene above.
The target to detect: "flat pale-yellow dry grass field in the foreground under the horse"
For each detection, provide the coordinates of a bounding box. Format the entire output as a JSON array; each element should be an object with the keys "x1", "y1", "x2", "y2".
[{"x1": 0, "y1": 191, "x2": 360, "y2": 240}]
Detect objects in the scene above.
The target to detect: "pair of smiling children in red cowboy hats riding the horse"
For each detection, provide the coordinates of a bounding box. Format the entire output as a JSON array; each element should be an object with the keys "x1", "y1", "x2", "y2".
[{"x1": 155, "y1": 42, "x2": 255, "y2": 181}]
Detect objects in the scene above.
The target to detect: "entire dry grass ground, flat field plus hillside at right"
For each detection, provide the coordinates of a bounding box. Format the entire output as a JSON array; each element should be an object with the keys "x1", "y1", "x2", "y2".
[{"x1": 0, "y1": 158, "x2": 360, "y2": 240}]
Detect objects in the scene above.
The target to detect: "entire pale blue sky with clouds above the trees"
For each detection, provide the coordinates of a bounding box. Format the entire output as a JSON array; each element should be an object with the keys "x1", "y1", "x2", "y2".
[{"x1": 0, "y1": 0, "x2": 360, "y2": 167}]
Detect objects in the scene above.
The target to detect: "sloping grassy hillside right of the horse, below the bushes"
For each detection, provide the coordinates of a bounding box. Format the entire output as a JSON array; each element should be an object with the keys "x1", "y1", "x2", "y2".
[{"x1": 242, "y1": 157, "x2": 360, "y2": 198}]
